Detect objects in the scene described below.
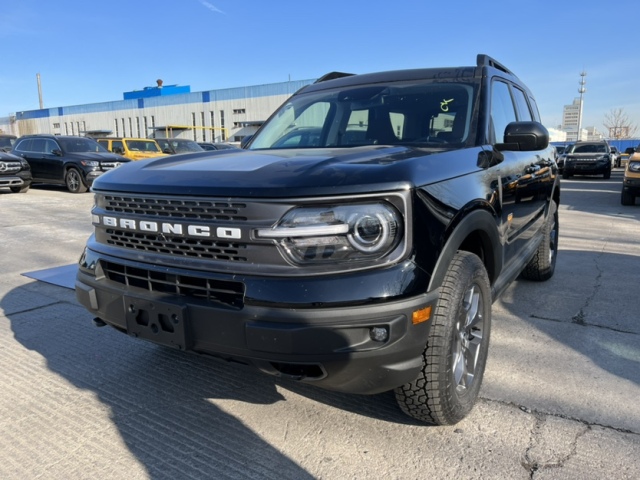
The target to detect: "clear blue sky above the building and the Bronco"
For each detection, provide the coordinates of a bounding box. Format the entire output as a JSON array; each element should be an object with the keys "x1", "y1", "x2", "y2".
[{"x1": 0, "y1": 0, "x2": 640, "y2": 135}]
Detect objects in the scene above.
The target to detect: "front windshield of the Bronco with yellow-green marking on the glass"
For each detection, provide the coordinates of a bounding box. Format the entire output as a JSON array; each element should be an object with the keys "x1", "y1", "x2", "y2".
[{"x1": 247, "y1": 81, "x2": 474, "y2": 150}]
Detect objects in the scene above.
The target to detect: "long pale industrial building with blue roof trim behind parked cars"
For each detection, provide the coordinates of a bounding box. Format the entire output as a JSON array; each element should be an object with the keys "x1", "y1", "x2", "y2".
[{"x1": 0, "y1": 79, "x2": 315, "y2": 142}]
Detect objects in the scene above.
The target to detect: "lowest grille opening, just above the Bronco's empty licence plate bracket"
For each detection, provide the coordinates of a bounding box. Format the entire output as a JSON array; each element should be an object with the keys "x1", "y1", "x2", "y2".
[{"x1": 100, "y1": 260, "x2": 244, "y2": 309}]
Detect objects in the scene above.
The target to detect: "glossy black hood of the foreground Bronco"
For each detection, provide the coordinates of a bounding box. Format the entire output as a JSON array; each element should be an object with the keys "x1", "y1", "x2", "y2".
[{"x1": 93, "y1": 146, "x2": 480, "y2": 198}]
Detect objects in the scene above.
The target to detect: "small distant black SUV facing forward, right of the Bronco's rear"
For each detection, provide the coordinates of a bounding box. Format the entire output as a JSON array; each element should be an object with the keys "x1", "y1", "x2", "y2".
[{"x1": 562, "y1": 141, "x2": 614, "y2": 179}]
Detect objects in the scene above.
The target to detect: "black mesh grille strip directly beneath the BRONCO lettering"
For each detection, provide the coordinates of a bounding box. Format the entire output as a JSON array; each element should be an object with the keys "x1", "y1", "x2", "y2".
[{"x1": 106, "y1": 228, "x2": 247, "y2": 262}]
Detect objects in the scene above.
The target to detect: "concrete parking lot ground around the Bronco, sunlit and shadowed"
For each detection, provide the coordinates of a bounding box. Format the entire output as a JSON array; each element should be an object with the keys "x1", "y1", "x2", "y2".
[{"x1": 0, "y1": 170, "x2": 640, "y2": 479}]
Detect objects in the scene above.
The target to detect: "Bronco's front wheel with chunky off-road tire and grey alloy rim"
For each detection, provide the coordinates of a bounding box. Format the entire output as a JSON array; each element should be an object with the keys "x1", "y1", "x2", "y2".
[{"x1": 395, "y1": 252, "x2": 491, "y2": 425}]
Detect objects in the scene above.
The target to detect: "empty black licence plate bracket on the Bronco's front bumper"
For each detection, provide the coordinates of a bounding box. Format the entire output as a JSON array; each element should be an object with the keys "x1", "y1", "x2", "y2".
[{"x1": 123, "y1": 296, "x2": 189, "y2": 350}]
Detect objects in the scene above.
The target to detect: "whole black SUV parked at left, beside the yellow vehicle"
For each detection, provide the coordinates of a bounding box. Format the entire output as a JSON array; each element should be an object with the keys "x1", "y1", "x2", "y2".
[{"x1": 12, "y1": 135, "x2": 129, "y2": 193}]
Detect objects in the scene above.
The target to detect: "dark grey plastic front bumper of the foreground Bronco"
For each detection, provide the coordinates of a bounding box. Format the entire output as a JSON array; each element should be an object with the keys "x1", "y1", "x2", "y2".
[{"x1": 76, "y1": 252, "x2": 438, "y2": 394}]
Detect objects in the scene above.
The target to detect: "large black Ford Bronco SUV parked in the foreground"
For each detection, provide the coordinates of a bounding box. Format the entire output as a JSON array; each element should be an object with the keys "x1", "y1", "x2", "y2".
[{"x1": 76, "y1": 55, "x2": 560, "y2": 424}]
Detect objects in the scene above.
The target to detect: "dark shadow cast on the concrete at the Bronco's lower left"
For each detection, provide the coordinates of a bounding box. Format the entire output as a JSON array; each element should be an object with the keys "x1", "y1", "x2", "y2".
[{"x1": 0, "y1": 283, "x2": 313, "y2": 480}]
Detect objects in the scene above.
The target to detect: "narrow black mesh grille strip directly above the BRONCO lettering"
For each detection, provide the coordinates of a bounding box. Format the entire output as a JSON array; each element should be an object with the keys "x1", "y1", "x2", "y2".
[{"x1": 101, "y1": 195, "x2": 247, "y2": 222}]
